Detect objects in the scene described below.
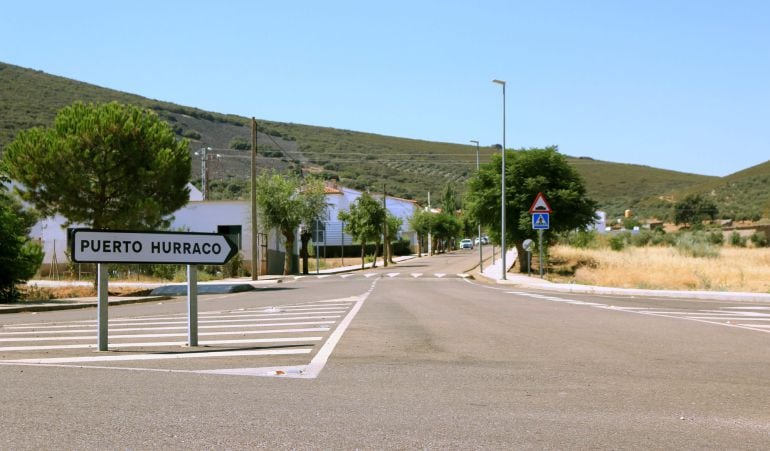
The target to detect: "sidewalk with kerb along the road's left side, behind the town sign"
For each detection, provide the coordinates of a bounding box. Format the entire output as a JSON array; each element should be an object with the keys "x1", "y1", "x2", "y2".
[{"x1": 0, "y1": 255, "x2": 417, "y2": 314}]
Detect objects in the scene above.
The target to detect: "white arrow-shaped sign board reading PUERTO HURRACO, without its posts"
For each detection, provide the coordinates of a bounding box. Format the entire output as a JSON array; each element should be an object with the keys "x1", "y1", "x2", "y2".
[{"x1": 70, "y1": 229, "x2": 238, "y2": 265}]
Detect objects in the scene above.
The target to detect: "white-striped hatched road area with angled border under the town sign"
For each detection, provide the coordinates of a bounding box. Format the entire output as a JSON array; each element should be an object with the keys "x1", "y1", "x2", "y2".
[{"x1": 0, "y1": 288, "x2": 377, "y2": 378}]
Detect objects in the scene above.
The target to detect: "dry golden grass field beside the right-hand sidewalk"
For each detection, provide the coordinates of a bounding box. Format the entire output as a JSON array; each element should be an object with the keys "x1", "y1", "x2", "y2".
[{"x1": 548, "y1": 245, "x2": 770, "y2": 293}]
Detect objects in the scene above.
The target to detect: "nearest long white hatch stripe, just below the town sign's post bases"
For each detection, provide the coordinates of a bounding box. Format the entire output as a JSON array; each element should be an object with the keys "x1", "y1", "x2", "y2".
[{"x1": 0, "y1": 348, "x2": 313, "y2": 365}]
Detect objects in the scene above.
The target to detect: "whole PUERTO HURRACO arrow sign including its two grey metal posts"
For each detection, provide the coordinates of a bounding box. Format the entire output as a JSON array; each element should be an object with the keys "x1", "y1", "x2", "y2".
[{"x1": 70, "y1": 229, "x2": 238, "y2": 351}]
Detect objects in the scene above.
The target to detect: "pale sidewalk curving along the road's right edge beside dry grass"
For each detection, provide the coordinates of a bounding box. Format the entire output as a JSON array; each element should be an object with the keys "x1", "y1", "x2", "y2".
[{"x1": 477, "y1": 249, "x2": 770, "y2": 303}]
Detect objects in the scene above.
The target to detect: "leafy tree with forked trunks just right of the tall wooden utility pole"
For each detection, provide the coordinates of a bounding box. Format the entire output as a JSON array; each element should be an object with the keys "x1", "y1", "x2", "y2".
[{"x1": 256, "y1": 172, "x2": 326, "y2": 275}]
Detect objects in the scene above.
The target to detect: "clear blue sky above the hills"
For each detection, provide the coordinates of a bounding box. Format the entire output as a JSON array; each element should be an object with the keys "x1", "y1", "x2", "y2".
[{"x1": 0, "y1": 0, "x2": 770, "y2": 175}]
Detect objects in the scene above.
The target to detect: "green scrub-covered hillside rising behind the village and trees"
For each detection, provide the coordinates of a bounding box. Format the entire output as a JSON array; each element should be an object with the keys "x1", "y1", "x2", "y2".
[{"x1": 0, "y1": 63, "x2": 770, "y2": 221}]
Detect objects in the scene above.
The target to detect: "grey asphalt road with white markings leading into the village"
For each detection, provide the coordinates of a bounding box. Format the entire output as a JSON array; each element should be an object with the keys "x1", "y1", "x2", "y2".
[{"x1": 0, "y1": 251, "x2": 770, "y2": 449}]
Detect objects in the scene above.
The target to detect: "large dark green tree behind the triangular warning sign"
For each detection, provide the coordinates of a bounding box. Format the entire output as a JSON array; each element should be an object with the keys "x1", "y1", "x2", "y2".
[{"x1": 466, "y1": 146, "x2": 596, "y2": 272}]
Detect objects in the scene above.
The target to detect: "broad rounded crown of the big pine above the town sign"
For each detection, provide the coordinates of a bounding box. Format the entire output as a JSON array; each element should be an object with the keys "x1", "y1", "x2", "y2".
[{"x1": 3, "y1": 102, "x2": 191, "y2": 230}]
